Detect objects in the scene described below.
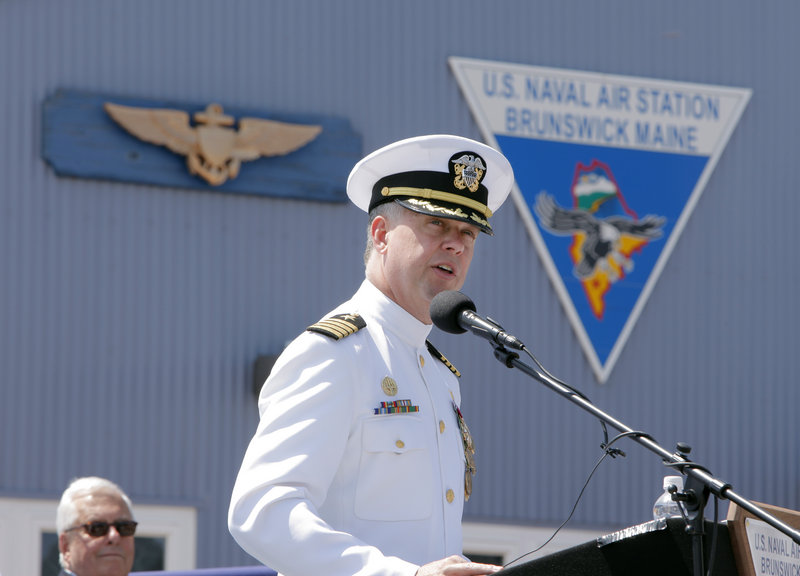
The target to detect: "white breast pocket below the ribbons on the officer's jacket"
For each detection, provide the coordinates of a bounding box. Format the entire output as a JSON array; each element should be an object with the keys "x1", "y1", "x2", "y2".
[{"x1": 355, "y1": 415, "x2": 433, "y2": 520}]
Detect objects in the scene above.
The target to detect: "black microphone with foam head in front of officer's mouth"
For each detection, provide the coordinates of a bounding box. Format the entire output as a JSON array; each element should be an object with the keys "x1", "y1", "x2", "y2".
[{"x1": 430, "y1": 290, "x2": 525, "y2": 350}]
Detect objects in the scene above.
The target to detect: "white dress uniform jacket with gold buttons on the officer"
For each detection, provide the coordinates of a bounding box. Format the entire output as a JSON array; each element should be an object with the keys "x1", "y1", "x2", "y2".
[{"x1": 228, "y1": 280, "x2": 465, "y2": 576}]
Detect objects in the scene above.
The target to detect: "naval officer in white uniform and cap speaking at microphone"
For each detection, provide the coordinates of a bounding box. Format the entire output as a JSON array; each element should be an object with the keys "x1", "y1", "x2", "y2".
[{"x1": 228, "y1": 135, "x2": 514, "y2": 576}]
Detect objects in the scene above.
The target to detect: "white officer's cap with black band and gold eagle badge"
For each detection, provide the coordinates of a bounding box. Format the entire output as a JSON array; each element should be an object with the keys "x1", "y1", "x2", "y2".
[{"x1": 347, "y1": 134, "x2": 514, "y2": 235}]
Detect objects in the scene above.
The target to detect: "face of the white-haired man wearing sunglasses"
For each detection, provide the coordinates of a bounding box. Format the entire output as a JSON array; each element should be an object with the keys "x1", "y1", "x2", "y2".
[{"x1": 59, "y1": 494, "x2": 134, "y2": 576}]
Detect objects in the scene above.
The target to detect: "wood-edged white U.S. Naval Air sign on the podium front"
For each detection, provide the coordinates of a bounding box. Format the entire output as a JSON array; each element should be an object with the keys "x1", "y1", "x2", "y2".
[{"x1": 728, "y1": 502, "x2": 800, "y2": 576}]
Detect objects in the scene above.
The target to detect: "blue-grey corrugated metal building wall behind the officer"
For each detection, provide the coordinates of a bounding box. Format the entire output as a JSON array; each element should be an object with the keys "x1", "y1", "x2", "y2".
[{"x1": 0, "y1": 0, "x2": 800, "y2": 567}]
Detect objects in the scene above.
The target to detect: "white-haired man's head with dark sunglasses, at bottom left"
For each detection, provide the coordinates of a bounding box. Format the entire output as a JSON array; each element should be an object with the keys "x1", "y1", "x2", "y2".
[{"x1": 56, "y1": 477, "x2": 136, "y2": 576}]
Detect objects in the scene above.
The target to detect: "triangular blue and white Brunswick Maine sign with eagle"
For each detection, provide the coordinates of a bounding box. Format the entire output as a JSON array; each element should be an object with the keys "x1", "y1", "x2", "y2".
[{"x1": 450, "y1": 57, "x2": 752, "y2": 383}]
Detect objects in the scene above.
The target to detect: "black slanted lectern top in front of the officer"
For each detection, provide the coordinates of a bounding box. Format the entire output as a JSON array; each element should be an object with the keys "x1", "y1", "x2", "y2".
[{"x1": 497, "y1": 518, "x2": 738, "y2": 576}]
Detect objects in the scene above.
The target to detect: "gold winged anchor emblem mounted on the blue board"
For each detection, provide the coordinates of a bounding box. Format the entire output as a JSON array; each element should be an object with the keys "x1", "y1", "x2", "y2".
[{"x1": 103, "y1": 102, "x2": 322, "y2": 186}]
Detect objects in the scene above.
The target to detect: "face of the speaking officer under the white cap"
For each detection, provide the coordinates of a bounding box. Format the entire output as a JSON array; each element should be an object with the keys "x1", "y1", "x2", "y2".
[{"x1": 374, "y1": 209, "x2": 480, "y2": 324}]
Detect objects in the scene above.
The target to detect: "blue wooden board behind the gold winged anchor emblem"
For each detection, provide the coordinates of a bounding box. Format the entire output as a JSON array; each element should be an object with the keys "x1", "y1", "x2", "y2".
[{"x1": 42, "y1": 90, "x2": 361, "y2": 202}]
